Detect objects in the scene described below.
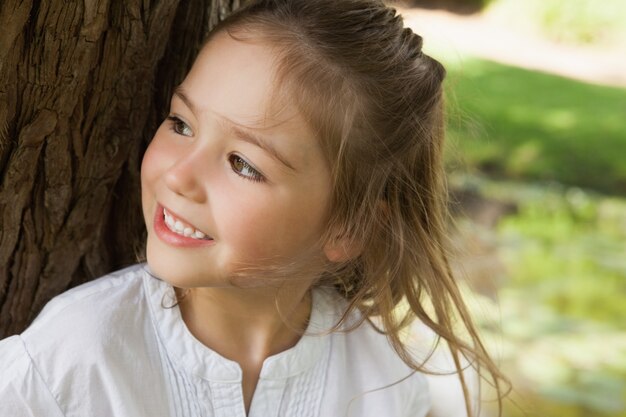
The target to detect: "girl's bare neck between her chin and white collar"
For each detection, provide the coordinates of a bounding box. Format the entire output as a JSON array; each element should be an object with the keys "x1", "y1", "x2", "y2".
[{"x1": 174, "y1": 287, "x2": 311, "y2": 368}]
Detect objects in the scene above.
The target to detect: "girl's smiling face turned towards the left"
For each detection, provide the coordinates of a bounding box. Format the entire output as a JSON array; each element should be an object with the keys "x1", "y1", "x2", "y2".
[{"x1": 141, "y1": 33, "x2": 330, "y2": 288}]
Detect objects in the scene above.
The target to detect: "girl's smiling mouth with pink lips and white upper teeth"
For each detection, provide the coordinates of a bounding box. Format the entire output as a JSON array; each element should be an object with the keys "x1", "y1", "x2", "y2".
[{"x1": 154, "y1": 203, "x2": 215, "y2": 247}]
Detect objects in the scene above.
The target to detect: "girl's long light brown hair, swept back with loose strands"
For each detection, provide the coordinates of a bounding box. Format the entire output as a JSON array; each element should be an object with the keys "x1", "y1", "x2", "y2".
[{"x1": 202, "y1": 0, "x2": 508, "y2": 415}]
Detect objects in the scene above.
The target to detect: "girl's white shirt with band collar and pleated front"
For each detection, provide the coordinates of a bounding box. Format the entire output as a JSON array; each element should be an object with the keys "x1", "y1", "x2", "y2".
[{"x1": 0, "y1": 265, "x2": 438, "y2": 417}]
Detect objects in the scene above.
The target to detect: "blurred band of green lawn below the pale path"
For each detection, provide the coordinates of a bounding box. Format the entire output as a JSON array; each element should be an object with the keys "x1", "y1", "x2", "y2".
[{"x1": 447, "y1": 57, "x2": 626, "y2": 195}]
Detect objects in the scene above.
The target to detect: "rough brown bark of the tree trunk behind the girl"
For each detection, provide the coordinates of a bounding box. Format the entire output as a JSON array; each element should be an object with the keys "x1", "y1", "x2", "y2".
[{"x1": 0, "y1": 0, "x2": 245, "y2": 338}]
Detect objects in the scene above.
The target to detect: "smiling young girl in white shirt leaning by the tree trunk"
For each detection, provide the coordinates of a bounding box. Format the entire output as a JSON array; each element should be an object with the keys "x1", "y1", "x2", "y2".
[{"x1": 0, "y1": 0, "x2": 508, "y2": 417}]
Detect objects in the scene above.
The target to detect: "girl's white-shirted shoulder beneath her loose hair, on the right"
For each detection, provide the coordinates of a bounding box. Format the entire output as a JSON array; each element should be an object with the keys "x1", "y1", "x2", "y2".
[{"x1": 324, "y1": 291, "x2": 478, "y2": 416}]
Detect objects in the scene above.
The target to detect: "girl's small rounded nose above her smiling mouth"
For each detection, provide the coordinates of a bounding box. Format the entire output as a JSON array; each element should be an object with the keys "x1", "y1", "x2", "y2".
[{"x1": 164, "y1": 149, "x2": 208, "y2": 203}]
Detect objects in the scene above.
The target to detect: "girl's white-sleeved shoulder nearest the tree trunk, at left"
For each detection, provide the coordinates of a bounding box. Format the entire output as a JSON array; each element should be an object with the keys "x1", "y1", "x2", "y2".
[{"x1": 0, "y1": 265, "x2": 168, "y2": 416}]
